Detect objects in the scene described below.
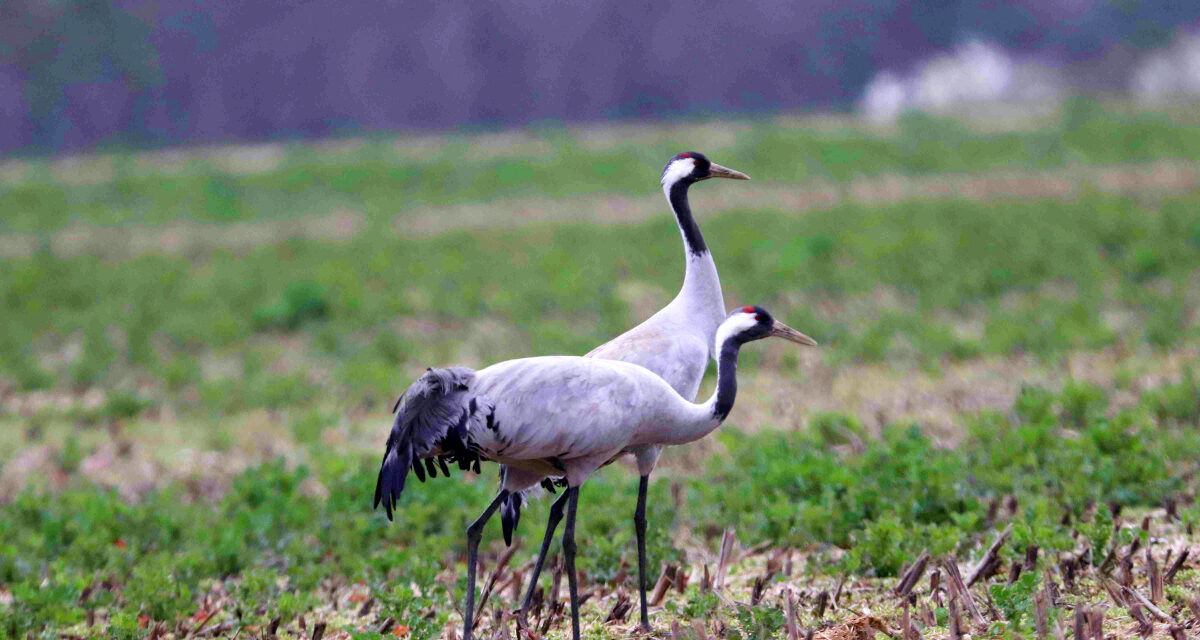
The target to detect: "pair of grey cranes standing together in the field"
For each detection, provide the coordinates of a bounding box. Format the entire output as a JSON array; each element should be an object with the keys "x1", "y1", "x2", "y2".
[{"x1": 374, "y1": 152, "x2": 816, "y2": 640}]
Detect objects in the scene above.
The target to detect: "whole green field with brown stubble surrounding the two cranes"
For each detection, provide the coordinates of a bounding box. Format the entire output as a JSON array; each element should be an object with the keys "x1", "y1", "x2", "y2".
[{"x1": 0, "y1": 102, "x2": 1200, "y2": 639}]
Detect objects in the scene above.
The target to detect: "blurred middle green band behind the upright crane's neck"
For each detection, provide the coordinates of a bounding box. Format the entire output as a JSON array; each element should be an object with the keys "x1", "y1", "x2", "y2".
[{"x1": 0, "y1": 187, "x2": 1200, "y2": 413}]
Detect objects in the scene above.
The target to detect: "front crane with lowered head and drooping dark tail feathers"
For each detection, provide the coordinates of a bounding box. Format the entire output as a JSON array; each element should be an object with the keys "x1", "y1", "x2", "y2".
[{"x1": 374, "y1": 306, "x2": 816, "y2": 640}]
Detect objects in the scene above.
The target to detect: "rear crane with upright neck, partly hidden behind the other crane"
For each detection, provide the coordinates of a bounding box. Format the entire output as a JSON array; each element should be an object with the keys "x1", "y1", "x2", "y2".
[{"x1": 500, "y1": 151, "x2": 750, "y2": 629}]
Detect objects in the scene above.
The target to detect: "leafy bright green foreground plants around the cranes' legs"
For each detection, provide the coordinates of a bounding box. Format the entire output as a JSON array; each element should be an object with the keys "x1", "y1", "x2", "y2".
[{"x1": 0, "y1": 381, "x2": 1200, "y2": 636}]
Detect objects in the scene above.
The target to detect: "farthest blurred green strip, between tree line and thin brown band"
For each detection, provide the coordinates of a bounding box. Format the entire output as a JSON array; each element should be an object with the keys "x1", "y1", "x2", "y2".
[{"x1": 0, "y1": 101, "x2": 1200, "y2": 232}]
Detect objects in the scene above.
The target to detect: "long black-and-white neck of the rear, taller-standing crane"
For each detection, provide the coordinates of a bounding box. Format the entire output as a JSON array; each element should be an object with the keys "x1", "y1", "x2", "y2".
[{"x1": 662, "y1": 180, "x2": 725, "y2": 343}]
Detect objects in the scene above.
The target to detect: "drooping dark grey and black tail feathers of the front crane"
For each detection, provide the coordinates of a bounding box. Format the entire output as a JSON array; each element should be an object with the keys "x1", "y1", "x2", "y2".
[{"x1": 374, "y1": 366, "x2": 491, "y2": 520}]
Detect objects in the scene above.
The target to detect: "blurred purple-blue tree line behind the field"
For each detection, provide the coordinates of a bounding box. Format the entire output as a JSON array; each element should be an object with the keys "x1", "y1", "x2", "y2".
[{"x1": 0, "y1": 0, "x2": 1200, "y2": 151}]
